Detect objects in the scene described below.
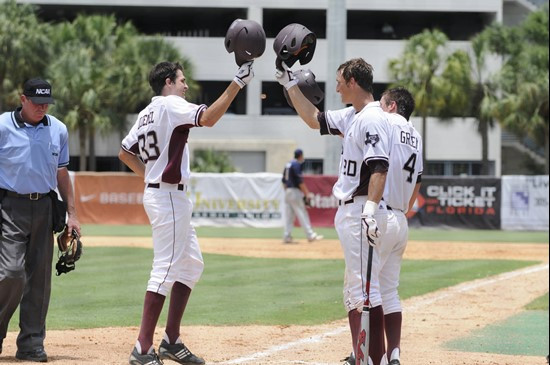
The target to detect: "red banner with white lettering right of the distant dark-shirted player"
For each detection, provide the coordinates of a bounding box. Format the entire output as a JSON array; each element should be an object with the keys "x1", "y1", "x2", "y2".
[{"x1": 304, "y1": 175, "x2": 338, "y2": 227}]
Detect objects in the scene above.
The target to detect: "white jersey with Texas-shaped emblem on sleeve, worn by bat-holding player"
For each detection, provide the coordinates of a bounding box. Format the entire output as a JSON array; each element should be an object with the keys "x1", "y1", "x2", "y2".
[{"x1": 319, "y1": 101, "x2": 390, "y2": 201}]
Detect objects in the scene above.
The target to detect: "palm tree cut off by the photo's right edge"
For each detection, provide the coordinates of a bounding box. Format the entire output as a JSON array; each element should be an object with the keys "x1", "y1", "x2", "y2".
[{"x1": 488, "y1": 3, "x2": 550, "y2": 174}]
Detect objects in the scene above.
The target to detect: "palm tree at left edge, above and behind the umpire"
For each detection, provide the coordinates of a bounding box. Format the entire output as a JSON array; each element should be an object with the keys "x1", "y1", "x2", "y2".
[{"x1": 0, "y1": 0, "x2": 50, "y2": 112}]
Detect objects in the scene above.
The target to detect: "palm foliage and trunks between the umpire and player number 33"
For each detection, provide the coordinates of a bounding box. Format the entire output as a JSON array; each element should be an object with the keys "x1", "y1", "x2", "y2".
[{"x1": 48, "y1": 15, "x2": 135, "y2": 171}]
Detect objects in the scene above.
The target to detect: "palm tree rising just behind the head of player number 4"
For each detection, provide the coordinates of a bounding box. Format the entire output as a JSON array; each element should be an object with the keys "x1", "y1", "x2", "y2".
[{"x1": 389, "y1": 30, "x2": 448, "y2": 165}]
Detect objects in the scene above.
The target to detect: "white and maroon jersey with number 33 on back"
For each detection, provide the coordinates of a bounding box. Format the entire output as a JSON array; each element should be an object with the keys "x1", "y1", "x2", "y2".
[{"x1": 122, "y1": 95, "x2": 206, "y2": 184}]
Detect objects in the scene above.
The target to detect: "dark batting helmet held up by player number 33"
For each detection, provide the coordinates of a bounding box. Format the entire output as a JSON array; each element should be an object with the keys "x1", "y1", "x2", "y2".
[{"x1": 225, "y1": 19, "x2": 265, "y2": 66}]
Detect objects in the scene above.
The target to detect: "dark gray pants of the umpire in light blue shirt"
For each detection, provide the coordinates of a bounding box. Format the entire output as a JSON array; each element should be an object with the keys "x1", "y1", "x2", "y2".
[{"x1": 0, "y1": 196, "x2": 53, "y2": 351}]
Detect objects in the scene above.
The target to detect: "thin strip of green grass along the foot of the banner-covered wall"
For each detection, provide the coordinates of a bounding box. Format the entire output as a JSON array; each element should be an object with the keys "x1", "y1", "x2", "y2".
[{"x1": 82, "y1": 225, "x2": 548, "y2": 244}]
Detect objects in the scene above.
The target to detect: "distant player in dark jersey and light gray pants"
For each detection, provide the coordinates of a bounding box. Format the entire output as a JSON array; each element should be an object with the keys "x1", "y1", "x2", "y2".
[{"x1": 282, "y1": 148, "x2": 323, "y2": 243}]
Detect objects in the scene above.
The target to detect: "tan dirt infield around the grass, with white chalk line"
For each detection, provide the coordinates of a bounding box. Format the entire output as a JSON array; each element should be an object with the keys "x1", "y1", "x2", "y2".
[{"x1": 0, "y1": 237, "x2": 549, "y2": 365}]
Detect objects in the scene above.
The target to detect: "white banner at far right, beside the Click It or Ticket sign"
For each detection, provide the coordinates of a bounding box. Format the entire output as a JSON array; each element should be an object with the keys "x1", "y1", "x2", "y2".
[{"x1": 501, "y1": 175, "x2": 549, "y2": 231}]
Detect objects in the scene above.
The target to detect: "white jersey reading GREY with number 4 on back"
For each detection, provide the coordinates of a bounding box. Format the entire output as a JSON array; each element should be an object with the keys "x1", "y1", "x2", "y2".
[{"x1": 383, "y1": 113, "x2": 423, "y2": 213}]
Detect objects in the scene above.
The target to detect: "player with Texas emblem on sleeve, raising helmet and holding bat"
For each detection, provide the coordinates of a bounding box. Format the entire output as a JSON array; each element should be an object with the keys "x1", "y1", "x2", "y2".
[{"x1": 275, "y1": 58, "x2": 391, "y2": 365}]
